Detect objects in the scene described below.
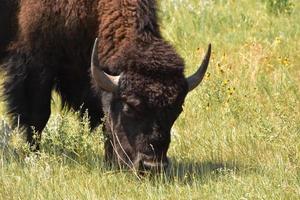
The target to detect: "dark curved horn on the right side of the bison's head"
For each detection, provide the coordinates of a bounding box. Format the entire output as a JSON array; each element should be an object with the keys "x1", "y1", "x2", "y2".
[{"x1": 187, "y1": 44, "x2": 211, "y2": 91}]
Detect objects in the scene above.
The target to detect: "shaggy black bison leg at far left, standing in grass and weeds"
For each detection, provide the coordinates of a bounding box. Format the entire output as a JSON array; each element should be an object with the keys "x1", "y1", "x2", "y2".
[{"x1": 4, "y1": 54, "x2": 54, "y2": 150}]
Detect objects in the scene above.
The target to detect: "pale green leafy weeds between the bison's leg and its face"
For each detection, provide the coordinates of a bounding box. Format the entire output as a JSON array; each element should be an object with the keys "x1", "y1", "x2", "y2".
[{"x1": 41, "y1": 112, "x2": 103, "y2": 164}]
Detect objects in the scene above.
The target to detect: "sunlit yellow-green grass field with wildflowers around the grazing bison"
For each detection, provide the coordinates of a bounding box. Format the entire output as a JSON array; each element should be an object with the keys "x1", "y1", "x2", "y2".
[{"x1": 0, "y1": 0, "x2": 300, "y2": 200}]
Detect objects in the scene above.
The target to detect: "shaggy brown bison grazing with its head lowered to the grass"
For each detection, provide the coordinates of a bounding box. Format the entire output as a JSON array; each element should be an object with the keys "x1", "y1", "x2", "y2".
[{"x1": 4, "y1": 0, "x2": 211, "y2": 172}]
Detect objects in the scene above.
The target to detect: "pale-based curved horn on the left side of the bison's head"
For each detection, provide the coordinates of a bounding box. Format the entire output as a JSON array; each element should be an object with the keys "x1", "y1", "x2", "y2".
[{"x1": 91, "y1": 38, "x2": 120, "y2": 92}]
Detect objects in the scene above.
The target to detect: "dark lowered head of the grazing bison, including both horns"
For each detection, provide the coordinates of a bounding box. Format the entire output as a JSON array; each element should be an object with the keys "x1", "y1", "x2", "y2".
[{"x1": 91, "y1": 40, "x2": 211, "y2": 170}]
